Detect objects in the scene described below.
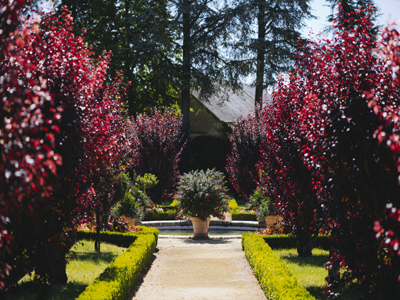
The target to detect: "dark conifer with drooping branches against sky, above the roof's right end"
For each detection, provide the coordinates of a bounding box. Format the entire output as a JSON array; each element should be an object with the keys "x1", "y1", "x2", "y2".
[{"x1": 226, "y1": 0, "x2": 313, "y2": 102}]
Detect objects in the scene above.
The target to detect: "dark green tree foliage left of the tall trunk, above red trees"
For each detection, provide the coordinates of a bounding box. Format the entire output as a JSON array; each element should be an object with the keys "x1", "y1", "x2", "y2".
[{"x1": 57, "y1": 0, "x2": 180, "y2": 114}]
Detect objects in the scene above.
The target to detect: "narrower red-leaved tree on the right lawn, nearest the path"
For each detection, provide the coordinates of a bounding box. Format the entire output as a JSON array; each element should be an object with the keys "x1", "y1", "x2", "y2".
[{"x1": 258, "y1": 73, "x2": 324, "y2": 256}]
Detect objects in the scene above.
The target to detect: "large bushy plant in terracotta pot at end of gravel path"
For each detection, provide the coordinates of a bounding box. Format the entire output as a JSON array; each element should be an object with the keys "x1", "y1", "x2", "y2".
[{"x1": 175, "y1": 169, "x2": 229, "y2": 238}]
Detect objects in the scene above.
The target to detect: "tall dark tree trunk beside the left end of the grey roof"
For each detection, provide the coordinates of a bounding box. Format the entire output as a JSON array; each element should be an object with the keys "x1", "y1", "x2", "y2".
[{"x1": 181, "y1": 1, "x2": 191, "y2": 172}]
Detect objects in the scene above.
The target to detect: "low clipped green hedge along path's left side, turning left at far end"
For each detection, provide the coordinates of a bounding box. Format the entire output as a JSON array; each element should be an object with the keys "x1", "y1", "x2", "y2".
[{"x1": 76, "y1": 226, "x2": 158, "y2": 300}]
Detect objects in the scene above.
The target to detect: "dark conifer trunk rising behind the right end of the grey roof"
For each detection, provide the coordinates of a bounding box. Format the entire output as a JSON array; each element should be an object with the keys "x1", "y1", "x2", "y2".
[{"x1": 255, "y1": 1, "x2": 266, "y2": 106}]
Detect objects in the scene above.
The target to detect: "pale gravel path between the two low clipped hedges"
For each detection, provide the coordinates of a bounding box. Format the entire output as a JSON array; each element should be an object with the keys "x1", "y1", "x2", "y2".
[{"x1": 129, "y1": 238, "x2": 266, "y2": 300}]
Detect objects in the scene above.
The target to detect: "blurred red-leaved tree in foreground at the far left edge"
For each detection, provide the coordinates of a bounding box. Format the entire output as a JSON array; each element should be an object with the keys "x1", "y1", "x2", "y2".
[{"x1": 0, "y1": 1, "x2": 61, "y2": 286}]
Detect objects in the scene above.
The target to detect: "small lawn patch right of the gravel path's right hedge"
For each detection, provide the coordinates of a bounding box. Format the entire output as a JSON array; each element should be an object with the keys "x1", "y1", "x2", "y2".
[{"x1": 274, "y1": 249, "x2": 359, "y2": 300}]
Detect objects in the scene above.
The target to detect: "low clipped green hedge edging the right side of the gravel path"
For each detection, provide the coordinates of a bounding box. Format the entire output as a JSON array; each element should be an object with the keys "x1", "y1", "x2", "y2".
[{"x1": 242, "y1": 233, "x2": 315, "y2": 300}]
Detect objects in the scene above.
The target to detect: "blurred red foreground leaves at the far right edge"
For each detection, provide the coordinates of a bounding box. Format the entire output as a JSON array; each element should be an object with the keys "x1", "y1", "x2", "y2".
[{"x1": 366, "y1": 24, "x2": 400, "y2": 294}]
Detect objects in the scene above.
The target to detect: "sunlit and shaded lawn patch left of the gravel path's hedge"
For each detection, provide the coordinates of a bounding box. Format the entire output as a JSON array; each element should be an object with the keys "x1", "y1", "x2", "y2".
[{"x1": 7, "y1": 240, "x2": 126, "y2": 300}]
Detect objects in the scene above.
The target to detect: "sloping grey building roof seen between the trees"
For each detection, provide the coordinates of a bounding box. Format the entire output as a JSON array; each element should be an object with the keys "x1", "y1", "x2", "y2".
[{"x1": 192, "y1": 84, "x2": 271, "y2": 123}]
